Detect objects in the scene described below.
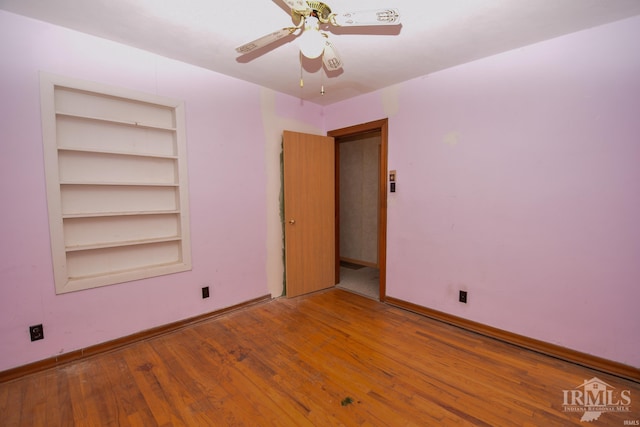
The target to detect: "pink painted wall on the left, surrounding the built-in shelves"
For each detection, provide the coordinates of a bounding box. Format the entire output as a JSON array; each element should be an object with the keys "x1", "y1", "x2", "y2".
[{"x1": 0, "y1": 11, "x2": 280, "y2": 370}]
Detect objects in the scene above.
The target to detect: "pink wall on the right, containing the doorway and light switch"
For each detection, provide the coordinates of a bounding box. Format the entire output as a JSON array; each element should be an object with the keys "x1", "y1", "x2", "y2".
[{"x1": 325, "y1": 18, "x2": 640, "y2": 367}]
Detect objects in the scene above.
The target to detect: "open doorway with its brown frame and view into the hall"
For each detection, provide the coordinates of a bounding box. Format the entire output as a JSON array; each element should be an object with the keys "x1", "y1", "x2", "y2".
[{"x1": 327, "y1": 119, "x2": 388, "y2": 301}]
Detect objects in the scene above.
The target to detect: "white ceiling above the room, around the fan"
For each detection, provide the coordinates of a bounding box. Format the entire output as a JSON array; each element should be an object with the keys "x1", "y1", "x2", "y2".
[{"x1": 0, "y1": 0, "x2": 640, "y2": 105}]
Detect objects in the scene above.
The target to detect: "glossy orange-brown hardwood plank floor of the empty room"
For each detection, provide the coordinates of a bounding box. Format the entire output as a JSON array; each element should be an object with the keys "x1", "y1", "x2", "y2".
[{"x1": 0, "y1": 289, "x2": 640, "y2": 426}]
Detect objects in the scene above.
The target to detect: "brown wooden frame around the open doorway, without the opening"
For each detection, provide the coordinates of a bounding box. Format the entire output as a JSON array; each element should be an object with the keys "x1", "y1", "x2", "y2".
[{"x1": 327, "y1": 118, "x2": 389, "y2": 301}]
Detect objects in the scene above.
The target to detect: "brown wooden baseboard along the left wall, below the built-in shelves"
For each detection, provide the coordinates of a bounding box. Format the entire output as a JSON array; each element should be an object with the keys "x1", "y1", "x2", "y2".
[{"x1": 0, "y1": 295, "x2": 272, "y2": 383}]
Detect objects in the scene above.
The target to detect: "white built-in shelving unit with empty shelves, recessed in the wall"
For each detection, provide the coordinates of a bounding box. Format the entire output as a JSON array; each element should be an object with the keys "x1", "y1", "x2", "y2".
[{"x1": 42, "y1": 74, "x2": 191, "y2": 293}]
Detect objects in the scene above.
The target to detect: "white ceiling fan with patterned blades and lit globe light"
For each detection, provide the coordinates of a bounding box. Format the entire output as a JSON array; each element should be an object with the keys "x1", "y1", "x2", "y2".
[{"x1": 236, "y1": 0, "x2": 400, "y2": 71}]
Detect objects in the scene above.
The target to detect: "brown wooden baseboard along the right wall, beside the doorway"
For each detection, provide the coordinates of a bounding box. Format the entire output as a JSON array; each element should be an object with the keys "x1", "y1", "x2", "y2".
[{"x1": 384, "y1": 297, "x2": 640, "y2": 383}]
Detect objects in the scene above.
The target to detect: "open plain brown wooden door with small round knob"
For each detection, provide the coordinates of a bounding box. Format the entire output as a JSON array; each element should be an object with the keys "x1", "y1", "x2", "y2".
[{"x1": 283, "y1": 131, "x2": 335, "y2": 298}]
